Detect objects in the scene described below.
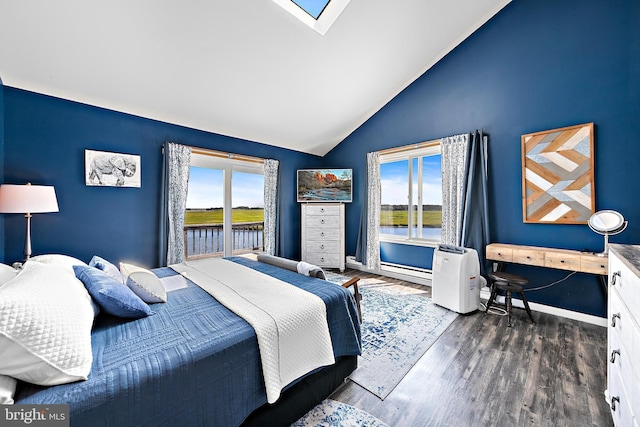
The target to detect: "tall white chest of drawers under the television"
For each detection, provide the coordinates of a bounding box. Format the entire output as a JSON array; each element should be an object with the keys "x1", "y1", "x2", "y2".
[{"x1": 301, "y1": 203, "x2": 345, "y2": 271}]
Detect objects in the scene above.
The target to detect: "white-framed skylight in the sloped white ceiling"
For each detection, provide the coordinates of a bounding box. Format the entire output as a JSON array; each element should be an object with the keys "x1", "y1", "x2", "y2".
[{"x1": 273, "y1": 0, "x2": 351, "y2": 35}]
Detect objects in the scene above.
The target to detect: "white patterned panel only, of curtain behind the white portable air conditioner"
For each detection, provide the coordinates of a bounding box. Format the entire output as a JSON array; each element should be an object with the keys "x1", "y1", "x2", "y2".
[{"x1": 440, "y1": 134, "x2": 469, "y2": 246}]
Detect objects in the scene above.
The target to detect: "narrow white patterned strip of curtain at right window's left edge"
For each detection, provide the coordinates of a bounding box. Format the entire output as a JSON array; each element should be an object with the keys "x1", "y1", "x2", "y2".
[{"x1": 365, "y1": 152, "x2": 381, "y2": 271}]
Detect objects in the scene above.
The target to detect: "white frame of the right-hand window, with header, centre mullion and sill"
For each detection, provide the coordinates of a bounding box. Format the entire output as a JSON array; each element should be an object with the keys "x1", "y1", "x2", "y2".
[{"x1": 378, "y1": 140, "x2": 442, "y2": 248}]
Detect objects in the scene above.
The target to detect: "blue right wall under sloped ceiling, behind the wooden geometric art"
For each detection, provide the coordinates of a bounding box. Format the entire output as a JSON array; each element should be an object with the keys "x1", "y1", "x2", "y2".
[{"x1": 326, "y1": 0, "x2": 640, "y2": 316}]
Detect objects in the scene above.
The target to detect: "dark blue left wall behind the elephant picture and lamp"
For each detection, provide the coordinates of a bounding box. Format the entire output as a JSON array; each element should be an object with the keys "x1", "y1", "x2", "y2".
[{"x1": 0, "y1": 87, "x2": 321, "y2": 267}]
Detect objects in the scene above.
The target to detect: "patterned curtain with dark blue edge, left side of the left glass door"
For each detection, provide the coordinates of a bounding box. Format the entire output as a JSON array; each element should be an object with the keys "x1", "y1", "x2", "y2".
[{"x1": 158, "y1": 142, "x2": 191, "y2": 266}]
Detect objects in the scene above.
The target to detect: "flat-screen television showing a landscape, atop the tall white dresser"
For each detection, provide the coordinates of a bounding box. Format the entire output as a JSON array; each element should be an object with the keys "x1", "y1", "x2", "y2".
[{"x1": 297, "y1": 169, "x2": 353, "y2": 203}]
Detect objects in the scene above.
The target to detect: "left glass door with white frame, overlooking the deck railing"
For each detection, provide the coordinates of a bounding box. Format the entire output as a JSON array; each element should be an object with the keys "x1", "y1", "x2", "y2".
[{"x1": 185, "y1": 153, "x2": 264, "y2": 259}]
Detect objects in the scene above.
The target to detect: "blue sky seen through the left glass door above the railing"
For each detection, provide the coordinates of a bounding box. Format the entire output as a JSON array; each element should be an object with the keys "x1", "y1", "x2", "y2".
[{"x1": 187, "y1": 166, "x2": 264, "y2": 209}]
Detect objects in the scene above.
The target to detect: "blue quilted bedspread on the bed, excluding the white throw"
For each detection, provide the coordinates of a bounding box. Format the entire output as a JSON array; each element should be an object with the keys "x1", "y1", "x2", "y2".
[{"x1": 16, "y1": 257, "x2": 360, "y2": 427}]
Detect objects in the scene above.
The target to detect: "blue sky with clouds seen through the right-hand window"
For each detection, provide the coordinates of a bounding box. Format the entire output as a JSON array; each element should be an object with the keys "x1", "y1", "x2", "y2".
[{"x1": 380, "y1": 156, "x2": 442, "y2": 205}]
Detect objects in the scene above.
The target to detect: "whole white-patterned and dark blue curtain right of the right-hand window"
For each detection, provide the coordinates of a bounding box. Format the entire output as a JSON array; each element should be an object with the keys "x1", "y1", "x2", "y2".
[{"x1": 441, "y1": 131, "x2": 491, "y2": 275}]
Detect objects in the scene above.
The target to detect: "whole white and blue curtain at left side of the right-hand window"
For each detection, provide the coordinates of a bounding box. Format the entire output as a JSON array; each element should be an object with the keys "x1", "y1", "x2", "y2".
[{"x1": 356, "y1": 152, "x2": 380, "y2": 271}]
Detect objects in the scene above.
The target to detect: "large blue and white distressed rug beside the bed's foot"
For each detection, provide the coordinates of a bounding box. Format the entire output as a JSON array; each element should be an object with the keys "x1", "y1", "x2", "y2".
[{"x1": 349, "y1": 279, "x2": 458, "y2": 400}]
